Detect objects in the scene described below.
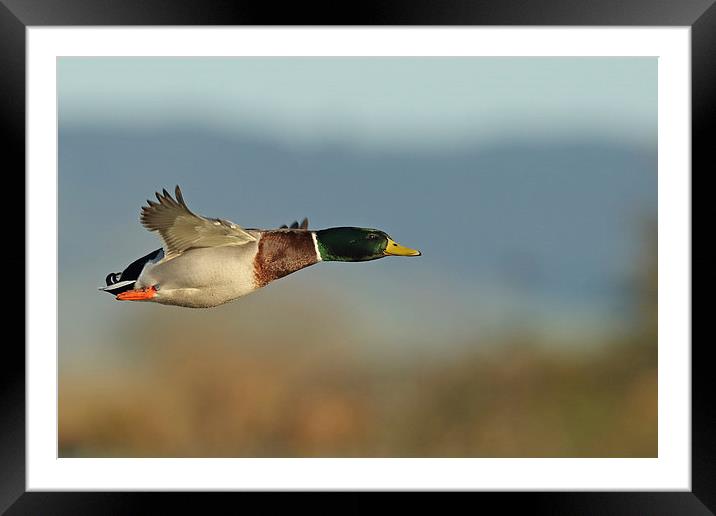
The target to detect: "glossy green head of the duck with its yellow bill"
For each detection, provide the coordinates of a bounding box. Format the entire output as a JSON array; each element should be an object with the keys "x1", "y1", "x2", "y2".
[{"x1": 316, "y1": 227, "x2": 420, "y2": 262}]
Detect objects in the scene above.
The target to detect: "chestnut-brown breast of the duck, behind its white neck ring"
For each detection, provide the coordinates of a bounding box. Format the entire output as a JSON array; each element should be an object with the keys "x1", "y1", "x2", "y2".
[{"x1": 254, "y1": 229, "x2": 318, "y2": 287}]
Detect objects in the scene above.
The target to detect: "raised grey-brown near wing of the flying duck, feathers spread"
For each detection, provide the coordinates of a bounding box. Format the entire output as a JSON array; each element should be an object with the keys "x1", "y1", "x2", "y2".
[{"x1": 139, "y1": 186, "x2": 256, "y2": 260}]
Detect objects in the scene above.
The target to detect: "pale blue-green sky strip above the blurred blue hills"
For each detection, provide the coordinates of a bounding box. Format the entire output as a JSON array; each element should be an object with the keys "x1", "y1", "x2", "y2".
[{"x1": 58, "y1": 58, "x2": 657, "y2": 151}]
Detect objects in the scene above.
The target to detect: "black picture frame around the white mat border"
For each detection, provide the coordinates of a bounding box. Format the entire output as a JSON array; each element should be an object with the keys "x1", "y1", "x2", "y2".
[{"x1": 0, "y1": 0, "x2": 716, "y2": 515}]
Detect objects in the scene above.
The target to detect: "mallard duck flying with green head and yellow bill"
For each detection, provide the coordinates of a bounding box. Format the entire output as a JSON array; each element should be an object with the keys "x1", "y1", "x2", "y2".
[{"x1": 100, "y1": 186, "x2": 421, "y2": 308}]
